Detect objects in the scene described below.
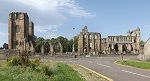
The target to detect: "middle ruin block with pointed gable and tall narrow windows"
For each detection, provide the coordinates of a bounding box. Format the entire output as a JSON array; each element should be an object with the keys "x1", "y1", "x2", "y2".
[{"x1": 78, "y1": 26, "x2": 101, "y2": 54}]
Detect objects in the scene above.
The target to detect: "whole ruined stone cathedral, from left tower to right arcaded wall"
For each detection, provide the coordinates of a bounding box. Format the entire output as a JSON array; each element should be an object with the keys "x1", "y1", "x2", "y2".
[{"x1": 8, "y1": 12, "x2": 141, "y2": 54}]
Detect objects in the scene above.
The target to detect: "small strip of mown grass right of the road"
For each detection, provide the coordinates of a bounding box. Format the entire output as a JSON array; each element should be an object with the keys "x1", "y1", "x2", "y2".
[{"x1": 117, "y1": 60, "x2": 150, "y2": 69}]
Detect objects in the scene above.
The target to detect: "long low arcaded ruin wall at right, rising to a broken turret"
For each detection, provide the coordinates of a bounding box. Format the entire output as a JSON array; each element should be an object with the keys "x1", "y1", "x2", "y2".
[{"x1": 102, "y1": 28, "x2": 140, "y2": 53}]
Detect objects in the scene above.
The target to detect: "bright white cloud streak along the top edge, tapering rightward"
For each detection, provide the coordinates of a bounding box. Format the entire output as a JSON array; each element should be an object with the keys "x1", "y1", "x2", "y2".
[{"x1": 13, "y1": 0, "x2": 94, "y2": 17}]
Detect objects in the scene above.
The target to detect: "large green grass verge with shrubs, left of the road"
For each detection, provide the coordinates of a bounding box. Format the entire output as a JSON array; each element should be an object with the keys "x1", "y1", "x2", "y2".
[{"x1": 0, "y1": 59, "x2": 84, "y2": 81}]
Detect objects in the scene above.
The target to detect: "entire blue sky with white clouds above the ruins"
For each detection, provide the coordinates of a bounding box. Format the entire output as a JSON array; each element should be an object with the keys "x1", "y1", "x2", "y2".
[{"x1": 0, "y1": 0, "x2": 150, "y2": 46}]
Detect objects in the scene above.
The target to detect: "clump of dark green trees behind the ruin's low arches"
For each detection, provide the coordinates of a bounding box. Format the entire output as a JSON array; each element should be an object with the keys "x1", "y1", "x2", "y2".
[{"x1": 35, "y1": 36, "x2": 78, "y2": 53}]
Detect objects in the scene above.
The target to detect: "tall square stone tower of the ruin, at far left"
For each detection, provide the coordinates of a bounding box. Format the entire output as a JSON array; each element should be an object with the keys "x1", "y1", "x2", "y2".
[{"x1": 8, "y1": 12, "x2": 35, "y2": 51}]
